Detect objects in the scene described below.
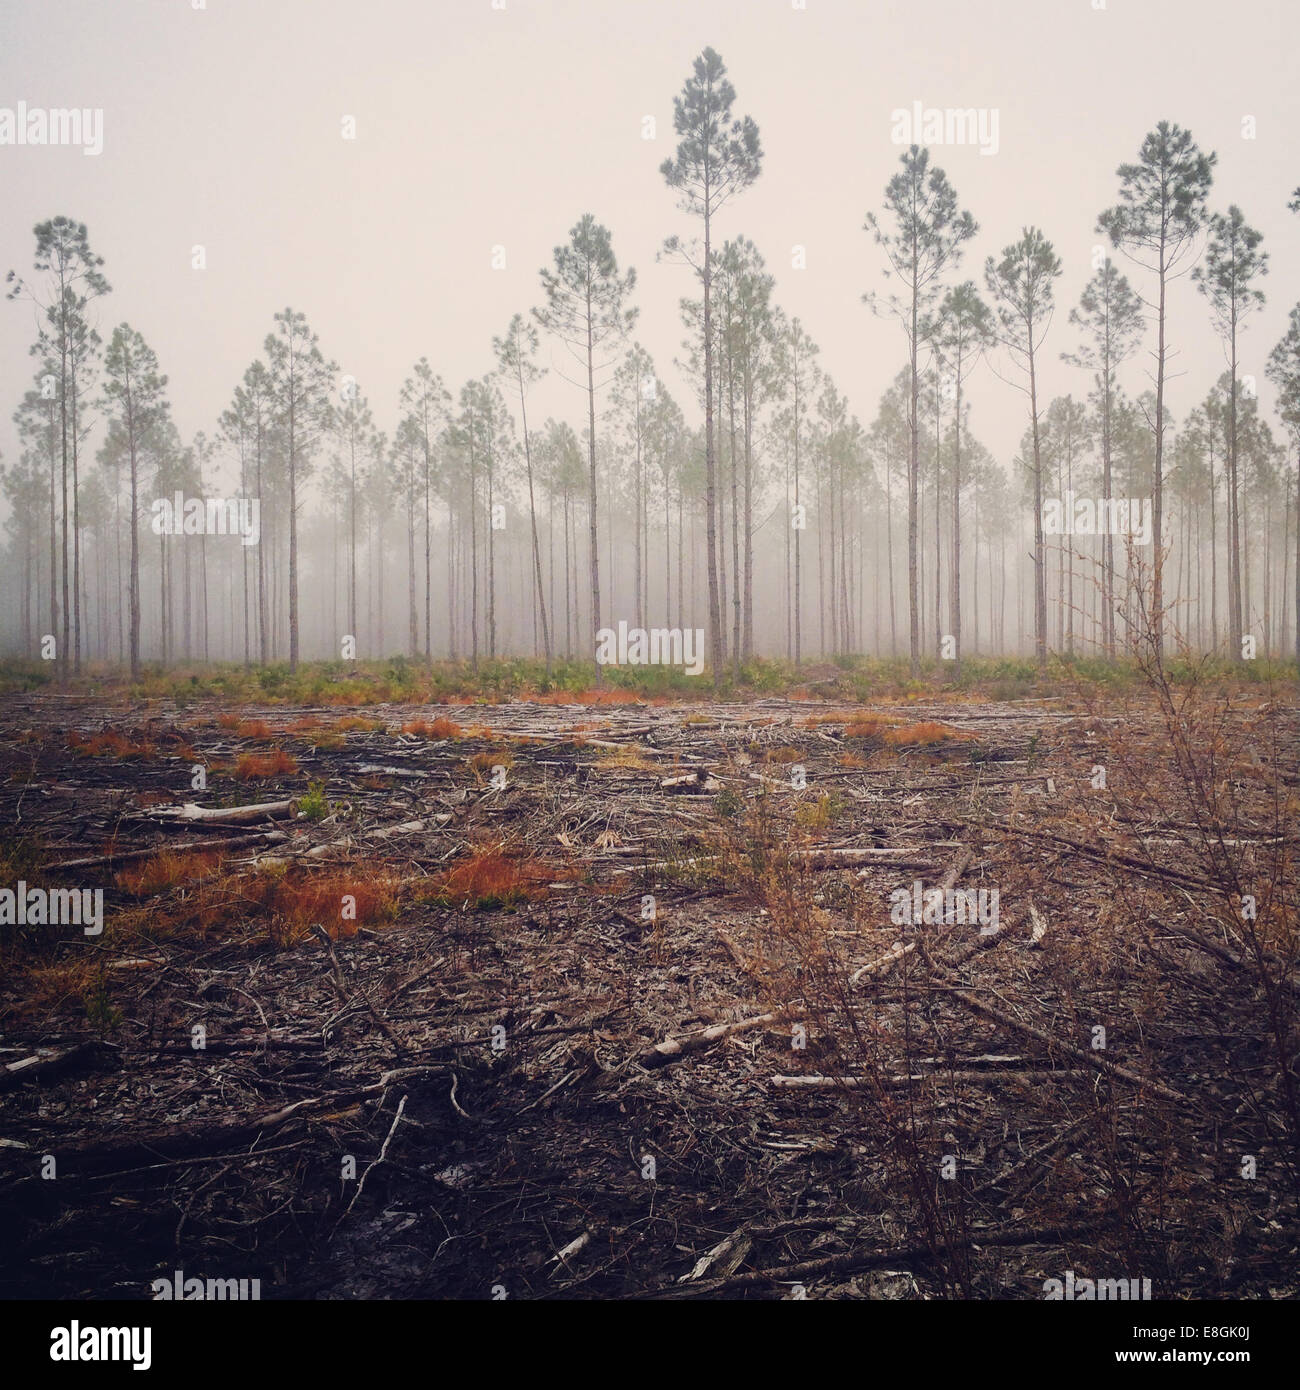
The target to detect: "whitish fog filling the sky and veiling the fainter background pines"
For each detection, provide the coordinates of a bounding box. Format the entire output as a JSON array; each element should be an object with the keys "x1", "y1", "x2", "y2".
[{"x1": 0, "y1": 0, "x2": 1300, "y2": 664}]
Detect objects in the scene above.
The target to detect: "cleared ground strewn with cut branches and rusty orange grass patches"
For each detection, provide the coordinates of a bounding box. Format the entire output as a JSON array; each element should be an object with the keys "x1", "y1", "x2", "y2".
[{"x1": 0, "y1": 688, "x2": 1300, "y2": 1298}]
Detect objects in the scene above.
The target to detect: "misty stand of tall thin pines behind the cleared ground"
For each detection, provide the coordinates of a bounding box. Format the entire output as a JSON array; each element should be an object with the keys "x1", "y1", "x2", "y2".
[{"x1": 0, "y1": 49, "x2": 1300, "y2": 681}]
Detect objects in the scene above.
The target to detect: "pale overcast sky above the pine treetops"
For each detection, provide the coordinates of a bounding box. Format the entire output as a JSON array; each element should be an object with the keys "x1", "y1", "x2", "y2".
[{"x1": 0, "y1": 0, "x2": 1300, "y2": 489}]
